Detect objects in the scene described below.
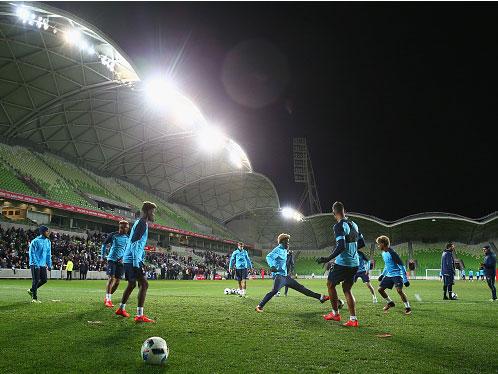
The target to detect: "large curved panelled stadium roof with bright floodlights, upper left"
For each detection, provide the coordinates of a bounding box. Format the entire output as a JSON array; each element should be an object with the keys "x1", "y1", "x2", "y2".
[{"x1": 0, "y1": 3, "x2": 278, "y2": 207}]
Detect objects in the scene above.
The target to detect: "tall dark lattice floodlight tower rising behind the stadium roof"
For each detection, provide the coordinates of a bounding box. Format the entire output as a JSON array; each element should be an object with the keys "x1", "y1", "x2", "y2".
[{"x1": 292, "y1": 138, "x2": 322, "y2": 215}]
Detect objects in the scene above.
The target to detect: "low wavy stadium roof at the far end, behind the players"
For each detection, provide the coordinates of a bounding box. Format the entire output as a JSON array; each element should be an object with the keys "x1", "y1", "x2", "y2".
[{"x1": 227, "y1": 209, "x2": 498, "y2": 250}]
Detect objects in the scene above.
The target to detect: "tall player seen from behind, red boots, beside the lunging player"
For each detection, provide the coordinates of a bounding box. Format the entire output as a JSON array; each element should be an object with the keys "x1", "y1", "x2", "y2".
[{"x1": 317, "y1": 201, "x2": 365, "y2": 327}]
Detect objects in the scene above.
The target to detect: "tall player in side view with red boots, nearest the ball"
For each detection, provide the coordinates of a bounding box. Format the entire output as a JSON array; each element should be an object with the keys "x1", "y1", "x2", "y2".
[{"x1": 116, "y1": 201, "x2": 156, "y2": 322}]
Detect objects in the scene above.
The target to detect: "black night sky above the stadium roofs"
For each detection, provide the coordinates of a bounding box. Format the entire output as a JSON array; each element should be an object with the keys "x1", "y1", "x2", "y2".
[{"x1": 48, "y1": 2, "x2": 498, "y2": 219}]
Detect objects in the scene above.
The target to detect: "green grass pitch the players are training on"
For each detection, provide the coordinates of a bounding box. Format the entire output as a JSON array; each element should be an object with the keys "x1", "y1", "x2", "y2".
[{"x1": 0, "y1": 280, "x2": 498, "y2": 373}]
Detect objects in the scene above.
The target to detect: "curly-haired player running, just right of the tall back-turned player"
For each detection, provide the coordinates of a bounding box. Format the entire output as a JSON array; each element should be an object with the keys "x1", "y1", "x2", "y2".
[{"x1": 375, "y1": 235, "x2": 412, "y2": 315}]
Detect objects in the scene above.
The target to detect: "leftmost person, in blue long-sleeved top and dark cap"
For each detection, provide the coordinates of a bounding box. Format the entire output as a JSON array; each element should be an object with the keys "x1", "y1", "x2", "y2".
[{"x1": 28, "y1": 225, "x2": 52, "y2": 303}]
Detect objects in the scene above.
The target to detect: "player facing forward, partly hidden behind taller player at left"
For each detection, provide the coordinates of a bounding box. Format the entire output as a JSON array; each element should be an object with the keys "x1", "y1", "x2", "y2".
[{"x1": 100, "y1": 220, "x2": 130, "y2": 308}]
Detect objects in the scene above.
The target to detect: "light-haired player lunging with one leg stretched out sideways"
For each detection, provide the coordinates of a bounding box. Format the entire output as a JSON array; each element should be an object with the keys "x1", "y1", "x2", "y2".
[{"x1": 256, "y1": 234, "x2": 329, "y2": 313}]
